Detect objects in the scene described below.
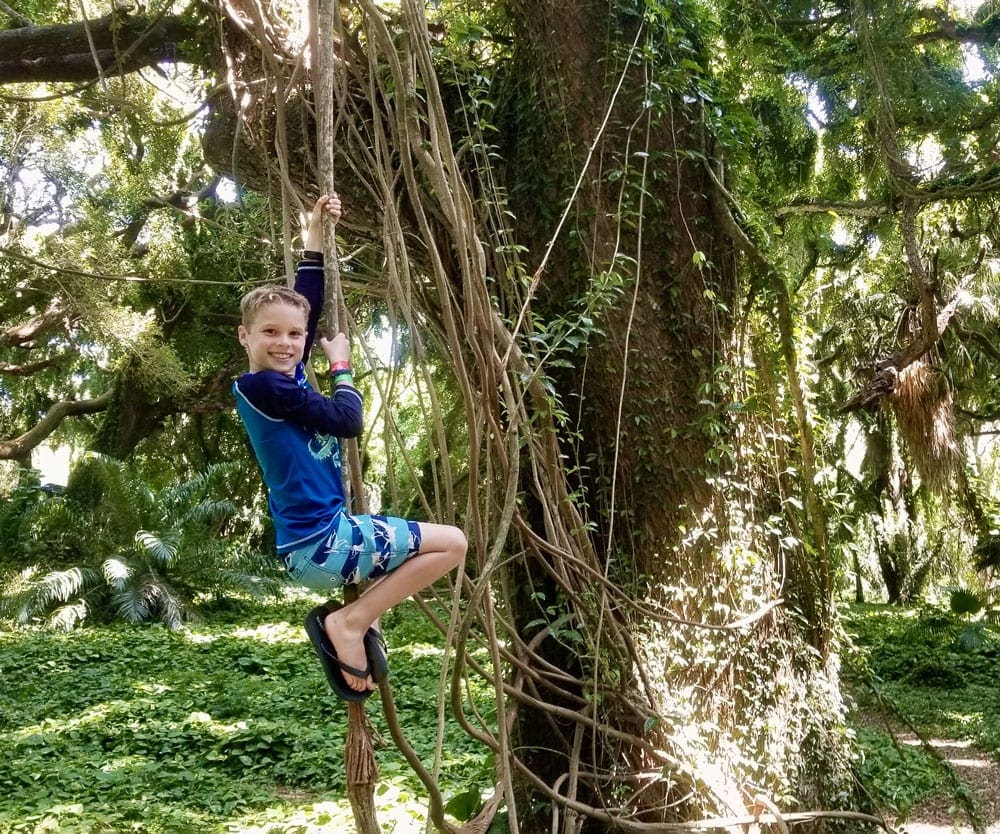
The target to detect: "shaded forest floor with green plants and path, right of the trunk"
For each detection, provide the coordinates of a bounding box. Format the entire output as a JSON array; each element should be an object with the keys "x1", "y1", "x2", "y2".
[{"x1": 844, "y1": 605, "x2": 1000, "y2": 834}]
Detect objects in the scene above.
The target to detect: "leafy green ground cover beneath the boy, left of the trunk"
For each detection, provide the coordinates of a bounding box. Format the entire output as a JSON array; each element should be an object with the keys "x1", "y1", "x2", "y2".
[{"x1": 0, "y1": 599, "x2": 491, "y2": 834}]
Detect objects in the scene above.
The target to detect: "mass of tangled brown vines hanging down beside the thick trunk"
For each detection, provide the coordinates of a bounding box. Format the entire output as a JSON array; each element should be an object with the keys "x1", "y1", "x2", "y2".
[{"x1": 209, "y1": 0, "x2": 876, "y2": 834}]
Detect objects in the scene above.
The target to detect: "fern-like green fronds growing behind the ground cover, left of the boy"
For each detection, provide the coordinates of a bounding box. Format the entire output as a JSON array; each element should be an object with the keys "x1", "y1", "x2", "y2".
[{"x1": 0, "y1": 456, "x2": 280, "y2": 628}]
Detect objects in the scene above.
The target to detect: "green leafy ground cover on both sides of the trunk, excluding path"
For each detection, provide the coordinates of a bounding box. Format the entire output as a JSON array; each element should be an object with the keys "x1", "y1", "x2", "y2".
[{"x1": 0, "y1": 593, "x2": 1000, "y2": 834}]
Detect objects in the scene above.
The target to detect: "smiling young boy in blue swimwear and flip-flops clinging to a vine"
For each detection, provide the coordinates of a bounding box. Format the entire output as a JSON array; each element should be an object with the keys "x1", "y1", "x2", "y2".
[{"x1": 233, "y1": 194, "x2": 467, "y2": 701}]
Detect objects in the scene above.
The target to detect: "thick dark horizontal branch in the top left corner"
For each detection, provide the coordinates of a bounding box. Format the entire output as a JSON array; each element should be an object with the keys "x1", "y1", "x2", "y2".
[{"x1": 0, "y1": 14, "x2": 199, "y2": 85}]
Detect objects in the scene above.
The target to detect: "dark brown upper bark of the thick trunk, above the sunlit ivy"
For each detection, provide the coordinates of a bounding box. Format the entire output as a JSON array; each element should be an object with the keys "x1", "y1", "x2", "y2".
[{"x1": 504, "y1": 3, "x2": 734, "y2": 580}]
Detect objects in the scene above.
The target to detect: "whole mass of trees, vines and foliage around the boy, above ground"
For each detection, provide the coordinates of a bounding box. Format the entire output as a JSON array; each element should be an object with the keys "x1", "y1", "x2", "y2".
[{"x1": 0, "y1": 0, "x2": 1000, "y2": 832}]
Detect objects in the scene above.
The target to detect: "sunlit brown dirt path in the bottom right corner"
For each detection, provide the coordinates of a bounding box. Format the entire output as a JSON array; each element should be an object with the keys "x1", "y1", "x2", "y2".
[{"x1": 899, "y1": 733, "x2": 1000, "y2": 834}]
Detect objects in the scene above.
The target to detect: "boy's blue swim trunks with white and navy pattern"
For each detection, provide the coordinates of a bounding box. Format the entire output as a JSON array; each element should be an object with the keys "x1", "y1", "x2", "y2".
[{"x1": 281, "y1": 513, "x2": 420, "y2": 591}]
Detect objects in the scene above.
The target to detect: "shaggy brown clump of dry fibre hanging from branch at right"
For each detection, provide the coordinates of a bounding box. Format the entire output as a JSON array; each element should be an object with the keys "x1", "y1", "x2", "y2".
[{"x1": 889, "y1": 360, "x2": 959, "y2": 492}]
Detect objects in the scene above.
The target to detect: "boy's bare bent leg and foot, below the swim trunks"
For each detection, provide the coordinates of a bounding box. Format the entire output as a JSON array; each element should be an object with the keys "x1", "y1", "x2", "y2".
[{"x1": 323, "y1": 522, "x2": 468, "y2": 692}]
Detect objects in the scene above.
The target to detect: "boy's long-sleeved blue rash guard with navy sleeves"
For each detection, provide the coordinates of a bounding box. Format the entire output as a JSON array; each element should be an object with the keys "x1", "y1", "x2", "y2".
[{"x1": 233, "y1": 252, "x2": 362, "y2": 554}]
